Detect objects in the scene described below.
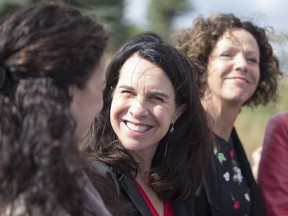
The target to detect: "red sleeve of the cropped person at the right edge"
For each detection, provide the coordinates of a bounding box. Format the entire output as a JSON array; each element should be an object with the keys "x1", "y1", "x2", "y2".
[{"x1": 258, "y1": 112, "x2": 288, "y2": 216}]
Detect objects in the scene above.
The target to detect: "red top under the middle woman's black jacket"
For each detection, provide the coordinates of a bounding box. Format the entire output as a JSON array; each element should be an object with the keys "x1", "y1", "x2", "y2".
[{"x1": 135, "y1": 179, "x2": 175, "y2": 216}]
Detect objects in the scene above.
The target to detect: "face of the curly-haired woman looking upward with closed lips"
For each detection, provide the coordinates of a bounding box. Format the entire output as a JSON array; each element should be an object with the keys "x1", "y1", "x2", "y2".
[{"x1": 206, "y1": 29, "x2": 260, "y2": 107}]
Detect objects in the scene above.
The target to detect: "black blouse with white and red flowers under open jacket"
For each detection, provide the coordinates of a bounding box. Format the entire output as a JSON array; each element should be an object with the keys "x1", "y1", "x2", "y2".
[{"x1": 211, "y1": 133, "x2": 251, "y2": 216}]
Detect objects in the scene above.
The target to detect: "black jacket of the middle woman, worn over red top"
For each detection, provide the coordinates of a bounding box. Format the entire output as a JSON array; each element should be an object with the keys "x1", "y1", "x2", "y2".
[{"x1": 92, "y1": 161, "x2": 195, "y2": 216}]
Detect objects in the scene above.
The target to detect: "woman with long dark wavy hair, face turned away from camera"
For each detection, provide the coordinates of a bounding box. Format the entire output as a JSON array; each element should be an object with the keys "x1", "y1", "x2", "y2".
[{"x1": 0, "y1": 3, "x2": 117, "y2": 216}]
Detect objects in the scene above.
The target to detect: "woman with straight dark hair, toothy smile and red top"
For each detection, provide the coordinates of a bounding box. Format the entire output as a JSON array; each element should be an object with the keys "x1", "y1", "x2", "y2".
[{"x1": 87, "y1": 33, "x2": 210, "y2": 216}]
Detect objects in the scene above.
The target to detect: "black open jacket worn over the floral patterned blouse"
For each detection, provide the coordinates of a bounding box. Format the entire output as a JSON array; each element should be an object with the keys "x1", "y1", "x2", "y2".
[{"x1": 194, "y1": 129, "x2": 267, "y2": 216}]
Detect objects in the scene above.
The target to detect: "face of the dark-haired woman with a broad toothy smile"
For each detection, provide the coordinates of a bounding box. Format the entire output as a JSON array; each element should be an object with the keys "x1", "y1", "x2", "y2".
[{"x1": 110, "y1": 54, "x2": 178, "y2": 157}]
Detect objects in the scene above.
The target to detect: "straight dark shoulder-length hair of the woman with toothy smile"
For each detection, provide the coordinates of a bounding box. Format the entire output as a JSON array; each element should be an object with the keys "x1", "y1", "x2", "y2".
[{"x1": 88, "y1": 33, "x2": 209, "y2": 199}]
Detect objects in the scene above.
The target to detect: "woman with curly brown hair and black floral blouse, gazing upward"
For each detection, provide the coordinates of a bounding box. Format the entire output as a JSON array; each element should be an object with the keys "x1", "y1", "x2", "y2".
[{"x1": 173, "y1": 14, "x2": 282, "y2": 216}]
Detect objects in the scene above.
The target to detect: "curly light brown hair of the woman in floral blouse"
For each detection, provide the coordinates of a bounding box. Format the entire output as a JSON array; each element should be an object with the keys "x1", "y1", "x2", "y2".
[{"x1": 172, "y1": 14, "x2": 282, "y2": 106}]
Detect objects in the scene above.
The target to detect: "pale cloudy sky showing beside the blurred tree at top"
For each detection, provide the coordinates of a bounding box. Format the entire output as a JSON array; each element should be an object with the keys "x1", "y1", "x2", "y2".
[{"x1": 126, "y1": 0, "x2": 288, "y2": 32}]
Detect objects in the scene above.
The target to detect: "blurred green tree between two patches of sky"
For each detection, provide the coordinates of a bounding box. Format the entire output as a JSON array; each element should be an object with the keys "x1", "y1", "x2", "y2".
[{"x1": 148, "y1": 0, "x2": 192, "y2": 38}]
